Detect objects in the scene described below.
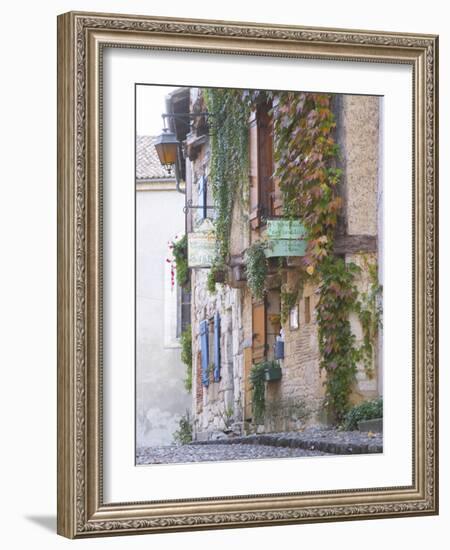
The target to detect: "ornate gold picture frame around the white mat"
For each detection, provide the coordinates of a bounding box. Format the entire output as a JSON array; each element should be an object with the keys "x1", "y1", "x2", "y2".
[{"x1": 58, "y1": 12, "x2": 438, "y2": 538}]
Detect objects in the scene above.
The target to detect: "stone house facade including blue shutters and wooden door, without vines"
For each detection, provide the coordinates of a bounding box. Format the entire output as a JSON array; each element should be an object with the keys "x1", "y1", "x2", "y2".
[{"x1": 163, "y1": 88, "x2": 382, "y2": 439}]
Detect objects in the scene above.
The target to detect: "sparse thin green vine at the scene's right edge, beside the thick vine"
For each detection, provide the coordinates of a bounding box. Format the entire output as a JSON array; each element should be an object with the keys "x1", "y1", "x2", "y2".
[{"x1": 356, "y1": 257, "x2": 383, "y2": 378}]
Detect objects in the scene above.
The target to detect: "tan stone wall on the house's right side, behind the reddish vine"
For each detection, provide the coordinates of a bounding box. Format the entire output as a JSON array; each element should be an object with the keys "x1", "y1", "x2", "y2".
[{"x1": 264, "y1": 95, "x2": 381, "y2": 431}]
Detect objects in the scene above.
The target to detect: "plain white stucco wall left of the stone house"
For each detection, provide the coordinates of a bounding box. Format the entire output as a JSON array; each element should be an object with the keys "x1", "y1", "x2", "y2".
[{"x1": 136, "y1": 186, "x2": 191, "y2": 448}]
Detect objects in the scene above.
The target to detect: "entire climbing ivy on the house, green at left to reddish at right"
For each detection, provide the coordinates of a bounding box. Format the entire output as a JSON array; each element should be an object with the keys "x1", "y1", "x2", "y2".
[{"x1": 204, "y1": 89, "x2": 381, "y2": 420}]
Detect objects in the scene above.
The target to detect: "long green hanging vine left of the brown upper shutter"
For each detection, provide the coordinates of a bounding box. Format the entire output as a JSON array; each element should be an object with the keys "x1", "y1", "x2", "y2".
[{"x1": 203, "y1": 88, "x2": 250, "y2": 263}]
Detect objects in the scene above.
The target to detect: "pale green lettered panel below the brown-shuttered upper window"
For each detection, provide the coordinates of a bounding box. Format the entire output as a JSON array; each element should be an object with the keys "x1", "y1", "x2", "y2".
[{"x1": 265, "y1": 219, "x2": 307, "y2": 258}]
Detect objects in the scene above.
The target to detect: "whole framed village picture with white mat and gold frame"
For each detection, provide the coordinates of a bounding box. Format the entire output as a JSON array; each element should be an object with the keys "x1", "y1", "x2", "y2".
[{"x1": 58, "y1": 12, "x2": 438, "y2": 538}]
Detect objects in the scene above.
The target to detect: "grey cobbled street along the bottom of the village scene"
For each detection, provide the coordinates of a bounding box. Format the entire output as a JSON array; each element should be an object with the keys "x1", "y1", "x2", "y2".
[{"x1": 136, "y1": 443, "x2": 327, "y2": 464}]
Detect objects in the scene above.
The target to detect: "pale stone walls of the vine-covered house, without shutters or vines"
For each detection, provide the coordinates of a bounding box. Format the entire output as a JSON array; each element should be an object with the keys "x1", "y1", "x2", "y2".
[{"x1": 190, "y1": 89, "x2": 381, "y2": 440}]
